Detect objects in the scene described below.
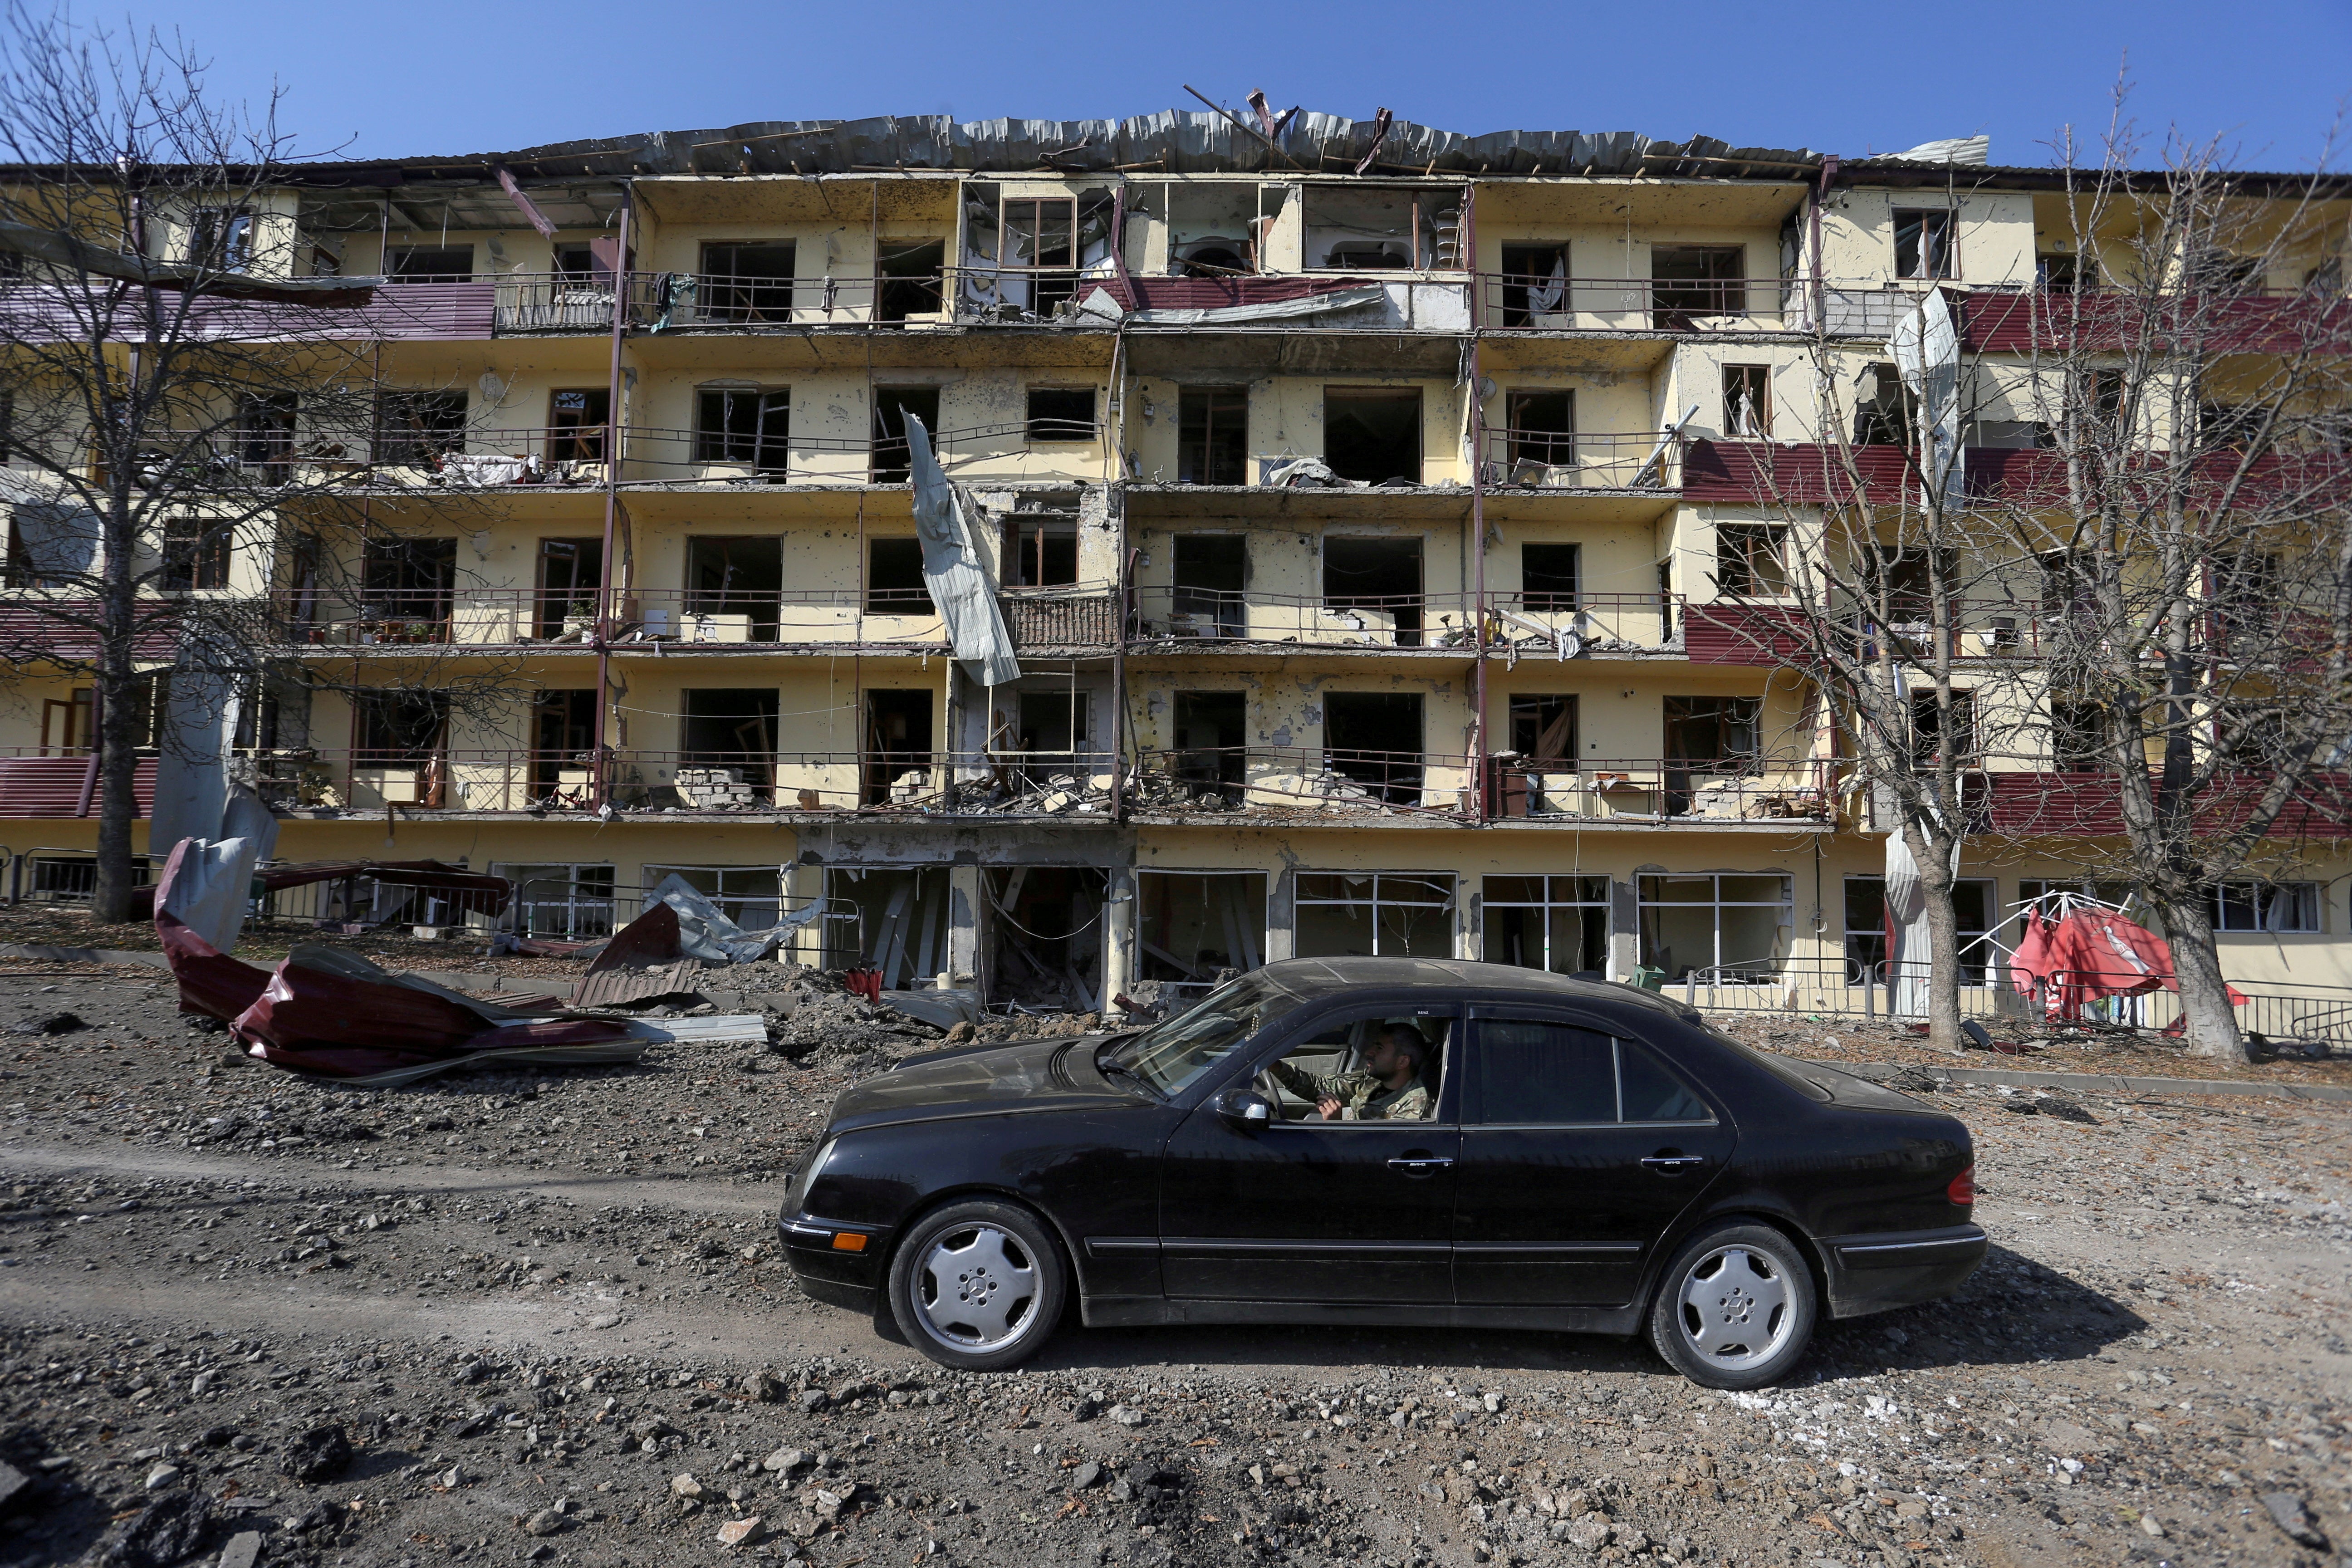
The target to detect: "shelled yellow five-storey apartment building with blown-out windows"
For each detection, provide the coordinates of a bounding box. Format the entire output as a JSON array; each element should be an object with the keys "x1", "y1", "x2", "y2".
[{"x1": 0, "y1": 111, "x2": 2347, "y2": 1011}]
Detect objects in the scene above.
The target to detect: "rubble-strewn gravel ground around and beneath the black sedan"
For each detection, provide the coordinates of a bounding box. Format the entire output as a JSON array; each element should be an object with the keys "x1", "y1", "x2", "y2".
[{"x1": 0, "y1": 971, "x2": 2352, "y2": 1568}]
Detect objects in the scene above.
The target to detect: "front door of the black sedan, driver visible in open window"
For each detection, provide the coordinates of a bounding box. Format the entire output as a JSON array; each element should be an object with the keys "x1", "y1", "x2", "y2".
[{"x1": 1160, "y1": 1001, "x2": 1460, "y2": 1307}]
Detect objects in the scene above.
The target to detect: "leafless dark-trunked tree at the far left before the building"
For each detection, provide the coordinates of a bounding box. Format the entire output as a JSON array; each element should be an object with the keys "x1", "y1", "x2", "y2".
[{"x1": 0, "y1": 0, "x2": 503, "y2": 921}]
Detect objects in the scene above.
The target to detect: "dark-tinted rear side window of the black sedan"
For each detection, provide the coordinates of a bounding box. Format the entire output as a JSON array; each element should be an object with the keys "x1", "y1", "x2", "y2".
[{"x1": 1475, "y1": 1018, "x2": 1715, "y2": 1126}]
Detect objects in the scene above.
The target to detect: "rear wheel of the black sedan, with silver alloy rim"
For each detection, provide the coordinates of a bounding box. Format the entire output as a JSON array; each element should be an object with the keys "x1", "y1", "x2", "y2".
[{"x1": 1649, "y1": 1225, "x2": 1816, "y2": 1389}]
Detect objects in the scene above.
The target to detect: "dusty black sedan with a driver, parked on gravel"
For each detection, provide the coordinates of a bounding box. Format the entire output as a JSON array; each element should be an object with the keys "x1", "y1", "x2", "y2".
[{"x1": 779, "y1": 959, "x2": 1985, "y2": 1389}]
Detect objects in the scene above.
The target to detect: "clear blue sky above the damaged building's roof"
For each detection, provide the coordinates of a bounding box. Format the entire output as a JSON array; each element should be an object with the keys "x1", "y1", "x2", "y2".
[{"x1": 78, "y1": 0, "x2": 2352, "y2": 169}]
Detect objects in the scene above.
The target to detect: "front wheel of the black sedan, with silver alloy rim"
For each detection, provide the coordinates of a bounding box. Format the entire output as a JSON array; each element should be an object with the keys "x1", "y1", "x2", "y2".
[{"x1": 889, "y1": 1199, "x2": 1070, "y2": 1373}]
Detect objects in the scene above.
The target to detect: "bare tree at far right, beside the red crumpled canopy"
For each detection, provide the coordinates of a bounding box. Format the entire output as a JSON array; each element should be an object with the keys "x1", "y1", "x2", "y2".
[{"x1": 1969, "y1": 120, "x2": 2352, "y2": 1058}]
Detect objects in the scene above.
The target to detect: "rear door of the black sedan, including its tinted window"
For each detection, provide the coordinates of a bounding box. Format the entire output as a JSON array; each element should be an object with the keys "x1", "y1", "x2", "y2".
[{"x1": 1454, "y1": 1009, "x2": 1738, "y2": 1307}]
